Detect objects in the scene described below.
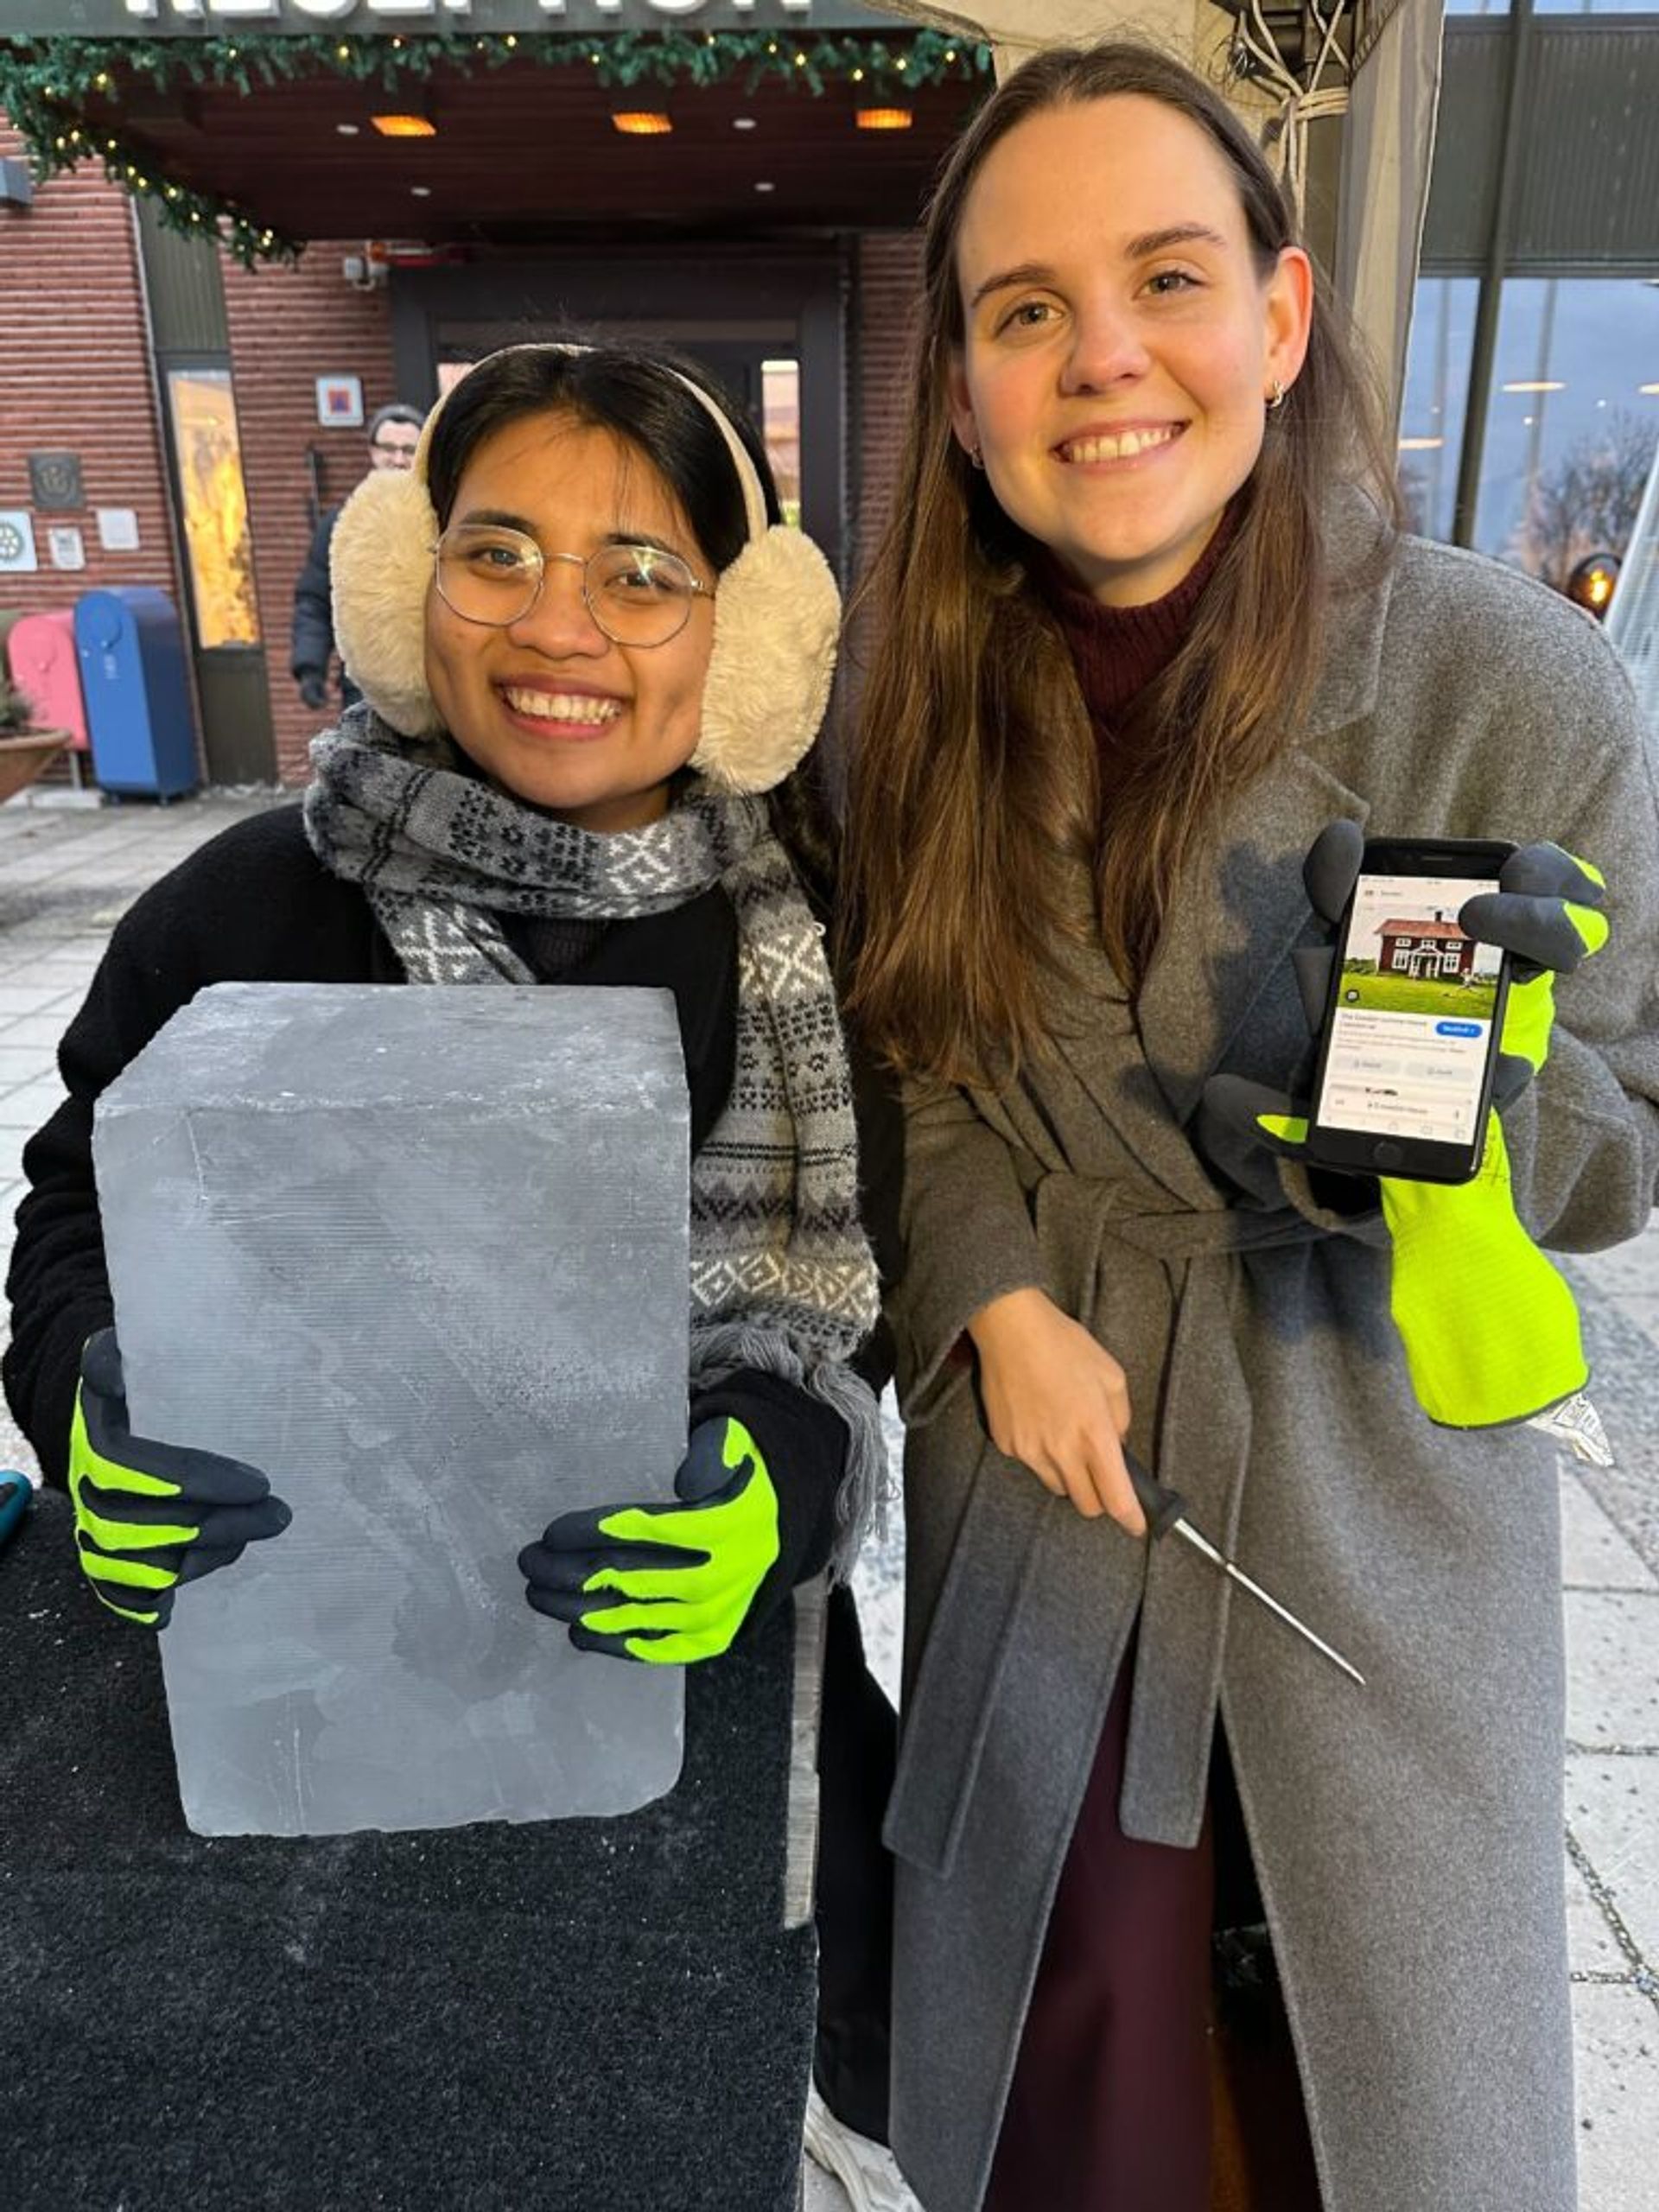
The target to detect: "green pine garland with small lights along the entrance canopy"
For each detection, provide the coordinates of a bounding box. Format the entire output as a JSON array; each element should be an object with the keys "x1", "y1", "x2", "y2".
[{"x1": 0, "y1": 29, "x2": 991, "y2": 268}]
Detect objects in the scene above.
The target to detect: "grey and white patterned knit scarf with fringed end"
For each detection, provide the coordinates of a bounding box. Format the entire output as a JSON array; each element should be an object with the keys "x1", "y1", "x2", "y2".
[{"x1": 305, "y1": 708, "x2": 882, "y2": 1573}]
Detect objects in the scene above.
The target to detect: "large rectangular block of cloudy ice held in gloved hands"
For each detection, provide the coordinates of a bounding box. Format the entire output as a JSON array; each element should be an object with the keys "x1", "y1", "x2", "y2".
[{"x1": 93, "y1": 984, "x2": 690, "y2": 1836}]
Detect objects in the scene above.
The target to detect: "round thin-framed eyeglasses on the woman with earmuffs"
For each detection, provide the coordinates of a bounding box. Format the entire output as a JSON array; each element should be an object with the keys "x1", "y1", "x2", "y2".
[{"x1": 435, "y1": 522, "x2": 712, "y2": 646}]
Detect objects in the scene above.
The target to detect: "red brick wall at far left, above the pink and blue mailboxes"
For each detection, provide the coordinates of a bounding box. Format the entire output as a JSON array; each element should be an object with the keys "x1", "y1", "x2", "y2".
[{"x1": 0, "y1": 115, "x2": 179, "y2": 641}]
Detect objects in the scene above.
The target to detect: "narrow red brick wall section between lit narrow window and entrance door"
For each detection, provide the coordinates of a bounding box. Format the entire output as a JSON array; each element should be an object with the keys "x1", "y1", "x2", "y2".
[{"x1": 224, "y1": 238, "x2": 402, "y2": 783}]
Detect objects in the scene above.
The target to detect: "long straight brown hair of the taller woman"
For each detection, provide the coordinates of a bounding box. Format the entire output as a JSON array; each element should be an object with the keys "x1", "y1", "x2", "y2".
[{"x1": 842, "y1": 40, "x2": 1394, "y2": 1082}]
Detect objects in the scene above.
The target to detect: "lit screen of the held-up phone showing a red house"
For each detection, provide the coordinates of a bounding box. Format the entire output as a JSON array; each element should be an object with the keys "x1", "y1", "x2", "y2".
[{"x1": 1314, "y1": 876, "x2": 1504, "y2": 1146}]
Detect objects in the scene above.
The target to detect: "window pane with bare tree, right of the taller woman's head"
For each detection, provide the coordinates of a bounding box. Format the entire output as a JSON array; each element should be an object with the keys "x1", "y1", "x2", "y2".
[{"x1": 1476, "y1": 276, "x2": 1659, "y2": 586}]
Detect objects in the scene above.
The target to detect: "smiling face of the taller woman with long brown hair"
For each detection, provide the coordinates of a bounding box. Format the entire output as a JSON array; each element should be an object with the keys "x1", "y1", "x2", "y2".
[{"x1": 951, "y1": 93, "x2": 1312, "y2": 606}]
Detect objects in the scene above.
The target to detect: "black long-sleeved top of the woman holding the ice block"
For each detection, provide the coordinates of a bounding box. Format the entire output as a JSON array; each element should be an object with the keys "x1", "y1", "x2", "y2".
[{"x1": 4, "y1": 807, "x2": 847, "y2": 1626}]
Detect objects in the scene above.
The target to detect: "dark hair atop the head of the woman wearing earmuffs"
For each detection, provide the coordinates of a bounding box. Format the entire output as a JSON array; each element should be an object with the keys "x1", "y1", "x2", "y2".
[{"x1": 427, "y1": 340, "x2": 781, "y2": 573}]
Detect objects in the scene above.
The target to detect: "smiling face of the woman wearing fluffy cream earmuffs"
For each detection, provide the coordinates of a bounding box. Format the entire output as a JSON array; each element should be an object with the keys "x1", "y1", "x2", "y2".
[{"x1": 427, "y1": 411, "x2": 715, "y2": 834}]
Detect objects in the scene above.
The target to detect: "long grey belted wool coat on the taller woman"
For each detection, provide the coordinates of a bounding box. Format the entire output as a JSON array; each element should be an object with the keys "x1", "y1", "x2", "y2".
[{"x1": 887, "y1": 506, "x2": 1659, "y2": 2212}]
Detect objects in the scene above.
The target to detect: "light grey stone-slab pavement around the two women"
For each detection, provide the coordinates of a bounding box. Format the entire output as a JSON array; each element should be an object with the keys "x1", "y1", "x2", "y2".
[{"x1": 0, "y1": 791, "x2": 1659, "y2": 2212}]
